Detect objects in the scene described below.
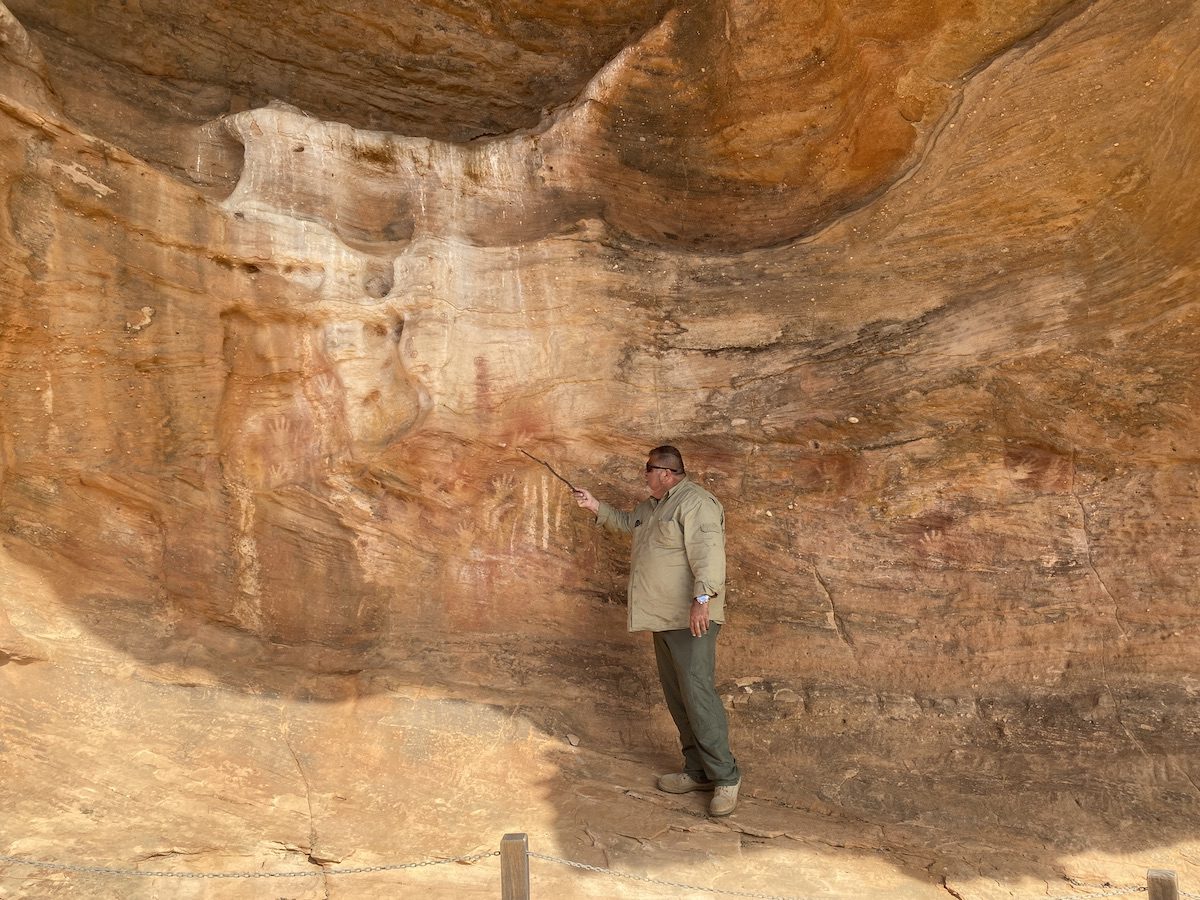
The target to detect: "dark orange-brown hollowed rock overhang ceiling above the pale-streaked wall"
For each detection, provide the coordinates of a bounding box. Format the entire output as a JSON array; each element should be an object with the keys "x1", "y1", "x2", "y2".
[{"x1": 2, "y1": 0, "x2": 1085, "y2": 248}]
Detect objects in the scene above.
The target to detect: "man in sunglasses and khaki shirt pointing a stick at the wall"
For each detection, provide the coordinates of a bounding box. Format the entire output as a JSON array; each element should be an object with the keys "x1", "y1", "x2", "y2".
[{"x1": 575, "y1": 446, "x2": 742, "y2": 816}]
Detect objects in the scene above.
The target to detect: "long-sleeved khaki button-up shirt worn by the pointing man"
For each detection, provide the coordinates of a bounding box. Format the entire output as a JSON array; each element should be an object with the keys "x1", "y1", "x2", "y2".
[{"x1": 596, "y1": 478, "x2": 725, "y2": 631}]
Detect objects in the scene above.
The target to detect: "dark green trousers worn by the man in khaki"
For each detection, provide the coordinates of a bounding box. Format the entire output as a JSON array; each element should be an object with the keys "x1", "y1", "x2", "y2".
[{"x1": 654, "y1": 623, "x2": 740, "y2": 785}]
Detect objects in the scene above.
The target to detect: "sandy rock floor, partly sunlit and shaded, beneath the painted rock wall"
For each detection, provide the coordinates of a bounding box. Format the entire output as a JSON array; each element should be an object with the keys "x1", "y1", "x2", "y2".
[{"x1": 0, "y1": 549, "x2": 1200, "y2": 900}]
